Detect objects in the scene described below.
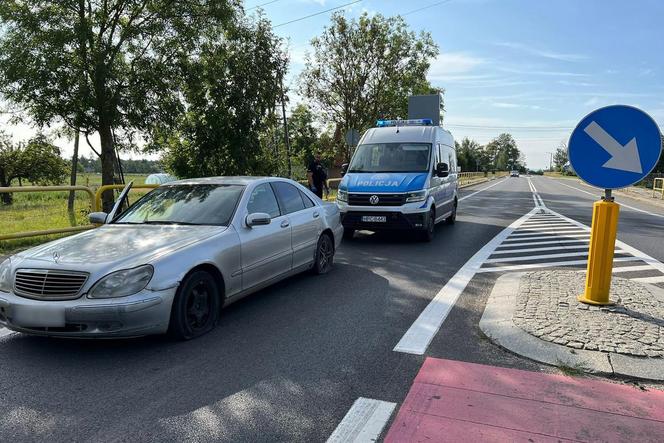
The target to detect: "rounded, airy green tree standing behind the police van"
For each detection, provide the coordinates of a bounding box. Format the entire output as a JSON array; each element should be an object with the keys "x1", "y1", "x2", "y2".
[{"x1": 300, "y1": 13, "x2": 440, "y2": 161}]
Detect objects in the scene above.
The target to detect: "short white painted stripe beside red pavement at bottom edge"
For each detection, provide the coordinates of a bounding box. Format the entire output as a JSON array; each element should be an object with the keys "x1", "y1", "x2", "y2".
[{"x1": 327, "y1": 397, "x2": 397, "y2": 443}]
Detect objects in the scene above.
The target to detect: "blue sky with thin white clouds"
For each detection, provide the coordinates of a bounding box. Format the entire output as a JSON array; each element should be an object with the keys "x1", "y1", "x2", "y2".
[{"x1": 5, "y1": 0, "x2": 664, "y2": 169}]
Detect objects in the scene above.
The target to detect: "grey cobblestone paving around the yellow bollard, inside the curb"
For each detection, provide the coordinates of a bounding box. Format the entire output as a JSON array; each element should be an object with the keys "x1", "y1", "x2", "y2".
[{"x1": 513, "y1": 271, "x2": 664, "y2": 358}]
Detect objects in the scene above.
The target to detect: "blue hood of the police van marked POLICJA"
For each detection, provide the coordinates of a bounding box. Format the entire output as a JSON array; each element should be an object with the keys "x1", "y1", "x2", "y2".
[{"x1": 339, "y1": 172, "x2": 429, "y2": 192}]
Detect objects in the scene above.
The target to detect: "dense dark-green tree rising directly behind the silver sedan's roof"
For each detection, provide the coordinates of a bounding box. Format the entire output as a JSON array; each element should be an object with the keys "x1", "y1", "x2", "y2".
[{"x1": 158, "y1": 17, "x2": 288, "y2": 177}]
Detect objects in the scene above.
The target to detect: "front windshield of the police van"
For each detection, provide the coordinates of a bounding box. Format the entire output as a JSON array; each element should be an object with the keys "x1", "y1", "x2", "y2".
[{"x1": 348, "y1": 143, "x2": 431, "y2": 172}]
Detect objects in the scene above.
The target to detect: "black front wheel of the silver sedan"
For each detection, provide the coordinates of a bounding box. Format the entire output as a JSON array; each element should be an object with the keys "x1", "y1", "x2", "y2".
[{"x1": 168, "y1": 270, "x2": 221, "y2": 340}]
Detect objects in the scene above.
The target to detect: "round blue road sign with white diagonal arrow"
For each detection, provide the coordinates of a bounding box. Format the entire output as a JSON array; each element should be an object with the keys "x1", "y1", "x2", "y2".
[{"x1": 567, "y1": 105, "x2": 662, "y2": 189}]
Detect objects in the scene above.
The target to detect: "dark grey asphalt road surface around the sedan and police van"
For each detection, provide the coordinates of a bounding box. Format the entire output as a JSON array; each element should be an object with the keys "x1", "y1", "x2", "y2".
[{"x1": 0, "y1": 177, "x2": 664, "y2": 442}]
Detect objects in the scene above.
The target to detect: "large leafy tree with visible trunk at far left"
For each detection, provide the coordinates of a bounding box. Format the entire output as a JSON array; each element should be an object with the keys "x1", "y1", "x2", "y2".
[{"x1": 0, "y1": 0, "x2": 239, "y2": 207}]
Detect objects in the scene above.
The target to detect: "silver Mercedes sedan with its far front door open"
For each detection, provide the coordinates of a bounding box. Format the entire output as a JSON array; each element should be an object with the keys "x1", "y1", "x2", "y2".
[{"x1": 0, "y1": 177, "x2": 343, "y2": 339}]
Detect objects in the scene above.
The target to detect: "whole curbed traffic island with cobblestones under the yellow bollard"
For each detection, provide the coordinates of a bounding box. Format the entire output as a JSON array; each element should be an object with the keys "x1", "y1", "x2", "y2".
[{"x1": 480, "y1": 270, "x2": 664, "y2": 381}]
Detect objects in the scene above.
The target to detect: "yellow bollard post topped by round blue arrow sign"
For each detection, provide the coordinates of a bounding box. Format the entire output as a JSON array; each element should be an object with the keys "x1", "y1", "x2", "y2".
[{"x1": 568, "y1": 105, "x2": 662, "y2": 305}]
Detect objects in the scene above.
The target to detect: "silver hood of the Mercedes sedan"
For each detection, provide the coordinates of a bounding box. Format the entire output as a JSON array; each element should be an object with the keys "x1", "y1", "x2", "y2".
[{"x1": 19, "y1": 225, "x2": 226, "y2": 271}]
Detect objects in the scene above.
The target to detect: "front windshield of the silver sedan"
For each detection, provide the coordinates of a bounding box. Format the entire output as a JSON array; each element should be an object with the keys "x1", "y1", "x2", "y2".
[{"x1": 115, "y1": 185, "x2": 244, "y2": 226}]
